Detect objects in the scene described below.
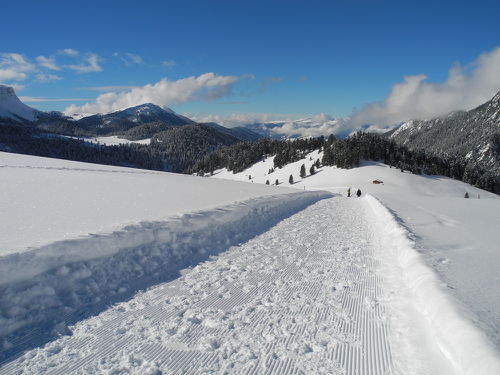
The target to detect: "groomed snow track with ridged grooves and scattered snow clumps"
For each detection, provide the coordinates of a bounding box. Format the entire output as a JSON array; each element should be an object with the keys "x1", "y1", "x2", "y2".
[{"x1": 0, "y1": 198, "x2": 458, "y2": 375}]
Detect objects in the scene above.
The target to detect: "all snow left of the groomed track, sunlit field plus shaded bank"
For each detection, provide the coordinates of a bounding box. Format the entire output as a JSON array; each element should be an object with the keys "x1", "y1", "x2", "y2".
[{"x1": 0, "y1": 153, "x2": 331, "y2": 363}]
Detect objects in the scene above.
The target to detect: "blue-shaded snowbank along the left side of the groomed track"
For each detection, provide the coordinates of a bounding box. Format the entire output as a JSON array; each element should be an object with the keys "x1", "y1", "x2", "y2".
[{"x1": 0, "y1": 192, "x2": 332, "y2": 350}]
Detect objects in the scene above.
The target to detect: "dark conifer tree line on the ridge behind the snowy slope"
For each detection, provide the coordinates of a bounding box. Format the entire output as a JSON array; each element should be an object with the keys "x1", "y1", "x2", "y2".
[{"x1": 191, "y1": 132, "x2": 500, "y2": 194}]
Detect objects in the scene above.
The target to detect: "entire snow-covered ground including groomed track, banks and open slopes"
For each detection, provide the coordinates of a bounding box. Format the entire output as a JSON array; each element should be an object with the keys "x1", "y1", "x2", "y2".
[{"x1": 0, "y1": 153, "x2": 500, "y2": 375}]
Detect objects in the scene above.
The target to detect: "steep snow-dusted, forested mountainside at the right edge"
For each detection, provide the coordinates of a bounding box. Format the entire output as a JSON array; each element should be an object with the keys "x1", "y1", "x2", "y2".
[{"x1": 389, "y1": 92, "x2": 500, "y2": 177}]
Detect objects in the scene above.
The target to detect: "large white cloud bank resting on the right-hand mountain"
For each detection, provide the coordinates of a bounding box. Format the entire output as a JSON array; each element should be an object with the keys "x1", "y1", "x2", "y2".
[{"x1": 235, "y1": 47, "x2": 500, "y2": 137}]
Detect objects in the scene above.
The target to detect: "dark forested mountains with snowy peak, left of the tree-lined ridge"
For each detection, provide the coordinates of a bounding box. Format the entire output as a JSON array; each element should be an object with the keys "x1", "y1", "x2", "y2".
[{"x1": 0, "y1": 85, "x2": 262, "y2": 172}]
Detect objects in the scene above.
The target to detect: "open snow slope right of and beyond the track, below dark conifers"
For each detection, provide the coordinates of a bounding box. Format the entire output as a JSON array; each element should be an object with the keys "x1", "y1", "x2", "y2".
[{"x1": 214, "y1": 151, "x2": 500, "y2": 349}]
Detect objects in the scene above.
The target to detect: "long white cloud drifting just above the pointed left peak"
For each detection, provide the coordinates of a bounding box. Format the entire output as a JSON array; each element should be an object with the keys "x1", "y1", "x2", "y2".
[{"x1": 65, "y1": 73, "x2": 241, "y2": 113}]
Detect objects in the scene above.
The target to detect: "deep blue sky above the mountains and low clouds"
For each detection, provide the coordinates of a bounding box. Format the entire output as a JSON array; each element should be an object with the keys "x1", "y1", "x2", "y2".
[{"x1": 0, "y1": 0, "x2": 500, "y2": 129}]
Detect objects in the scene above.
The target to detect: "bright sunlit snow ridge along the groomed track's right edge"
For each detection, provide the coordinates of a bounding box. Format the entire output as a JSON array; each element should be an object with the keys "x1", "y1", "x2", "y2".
[{"x1": 365, "y1": 195, "x2": 500, "y2": 375}]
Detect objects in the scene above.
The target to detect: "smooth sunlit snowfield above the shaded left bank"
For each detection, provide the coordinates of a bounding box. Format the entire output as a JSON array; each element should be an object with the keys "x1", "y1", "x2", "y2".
[{"x1": 0, "y1": 152, "x2": 295, "y2": 256}]
